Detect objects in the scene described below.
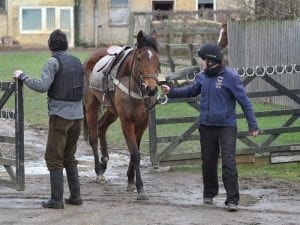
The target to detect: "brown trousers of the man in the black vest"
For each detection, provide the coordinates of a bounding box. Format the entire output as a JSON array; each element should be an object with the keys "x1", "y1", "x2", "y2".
[{"x1": 45, "y1": 116, "x2": 81, "y2": 170}]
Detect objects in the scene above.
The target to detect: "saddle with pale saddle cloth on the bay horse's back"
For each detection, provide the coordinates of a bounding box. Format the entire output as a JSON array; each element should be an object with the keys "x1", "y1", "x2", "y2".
[{"x1": 90, "y1": 46, "x2": 132, "y2": 94}]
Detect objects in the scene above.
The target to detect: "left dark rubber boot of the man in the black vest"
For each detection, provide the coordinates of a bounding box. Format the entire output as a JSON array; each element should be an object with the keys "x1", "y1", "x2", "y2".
[{"x1": 42, "y1": 170, "x2": 64, "y2": 209}]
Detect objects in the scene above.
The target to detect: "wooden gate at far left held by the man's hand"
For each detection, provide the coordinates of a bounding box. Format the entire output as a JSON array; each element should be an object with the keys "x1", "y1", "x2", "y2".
[{"x1": 0, "y1": 80, "x2": 25, "y2": 191}]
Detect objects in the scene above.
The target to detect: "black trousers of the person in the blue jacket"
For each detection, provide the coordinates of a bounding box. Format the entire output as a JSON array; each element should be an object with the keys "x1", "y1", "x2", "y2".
[{"x1": 199, "y1": 125, "x2": 239, "y2": 204}]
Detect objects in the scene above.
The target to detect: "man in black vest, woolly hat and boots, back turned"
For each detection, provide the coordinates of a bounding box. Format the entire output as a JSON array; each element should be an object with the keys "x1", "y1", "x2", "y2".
[{"x1": 13, "y1": 30, "x2": 84, "y2": 209}]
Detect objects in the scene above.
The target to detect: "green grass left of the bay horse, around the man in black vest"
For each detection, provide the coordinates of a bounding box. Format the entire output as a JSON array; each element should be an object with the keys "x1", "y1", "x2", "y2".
[{"x1": 0, "y1": 50, "x2": 90, "y2": 126}]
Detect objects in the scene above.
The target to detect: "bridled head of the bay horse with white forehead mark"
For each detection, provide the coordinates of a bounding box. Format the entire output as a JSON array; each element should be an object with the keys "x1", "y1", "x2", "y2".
[{"x1": 135, "y1": 31, "x2": 159, "y2": 96}]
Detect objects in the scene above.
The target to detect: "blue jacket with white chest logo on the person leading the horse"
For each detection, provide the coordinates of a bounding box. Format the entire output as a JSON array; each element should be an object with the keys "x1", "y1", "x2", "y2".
[{"x1": 168, "y1": 67, "x2": 258, "y2": 131}]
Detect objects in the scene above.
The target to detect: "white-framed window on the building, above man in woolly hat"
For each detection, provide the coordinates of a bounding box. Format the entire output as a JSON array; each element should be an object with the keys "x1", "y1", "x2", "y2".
[{"x1": 20, "y1": 7, "x2": 73, "y2": 34}]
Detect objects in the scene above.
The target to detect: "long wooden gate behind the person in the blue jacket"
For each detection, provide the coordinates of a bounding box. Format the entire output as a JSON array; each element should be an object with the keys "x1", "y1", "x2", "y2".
[{"x1": 149, "y1": 71, "x2": 300, "y2": 166}]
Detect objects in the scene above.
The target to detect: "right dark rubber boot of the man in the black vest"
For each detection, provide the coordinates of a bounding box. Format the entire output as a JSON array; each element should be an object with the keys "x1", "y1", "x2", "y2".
[{"x1": 65, "y1": 167, "x2": 82, "y2": 205}]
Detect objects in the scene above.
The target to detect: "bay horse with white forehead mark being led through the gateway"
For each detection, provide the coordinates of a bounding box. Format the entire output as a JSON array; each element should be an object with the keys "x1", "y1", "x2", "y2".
[{"x1": 83, "y1": 31, "x2": 159, "y2": 200}]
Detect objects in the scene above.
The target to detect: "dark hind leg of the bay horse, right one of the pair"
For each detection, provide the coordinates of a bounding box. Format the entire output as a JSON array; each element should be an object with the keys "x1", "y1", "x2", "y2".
[{"x1": 98, "y1": 111, "x2": 118, "y2": 178}]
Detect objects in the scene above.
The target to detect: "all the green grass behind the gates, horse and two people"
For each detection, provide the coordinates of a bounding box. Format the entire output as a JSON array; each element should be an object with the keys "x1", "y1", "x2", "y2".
[{"x1": 0, "y1": 50, "x2": 300, "y2": 154}]
